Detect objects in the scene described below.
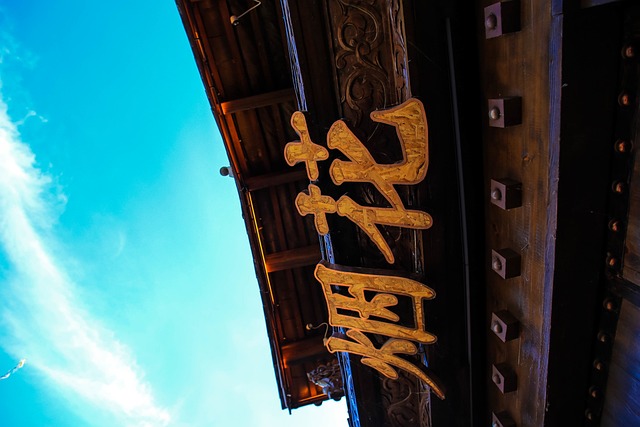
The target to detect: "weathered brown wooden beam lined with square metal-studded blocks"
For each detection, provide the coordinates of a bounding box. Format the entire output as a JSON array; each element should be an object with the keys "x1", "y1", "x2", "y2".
[{"x1": 476, "y1": 0, "x2": 561, "y2": 426}]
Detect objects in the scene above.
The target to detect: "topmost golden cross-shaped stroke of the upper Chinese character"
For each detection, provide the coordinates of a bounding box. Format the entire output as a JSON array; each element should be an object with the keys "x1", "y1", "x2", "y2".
[{"x1": 284, "y1": 111, "x2": 329, "y2": 181}]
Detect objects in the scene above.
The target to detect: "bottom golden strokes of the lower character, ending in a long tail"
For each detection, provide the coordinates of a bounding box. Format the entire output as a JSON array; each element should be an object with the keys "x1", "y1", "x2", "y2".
[{"x1": 325, "y1": 329, "x2": 445, "y2": 399}]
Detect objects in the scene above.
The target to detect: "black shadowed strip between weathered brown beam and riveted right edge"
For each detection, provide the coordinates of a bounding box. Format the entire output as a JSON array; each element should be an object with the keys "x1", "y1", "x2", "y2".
[{"x1": 546, "y1": 3, "x2": 620, "y2": 425}]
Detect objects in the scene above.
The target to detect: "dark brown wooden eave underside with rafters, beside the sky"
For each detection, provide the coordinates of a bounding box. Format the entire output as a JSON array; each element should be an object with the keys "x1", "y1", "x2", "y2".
[{"x1": 177, "y1": 0, "x2": 333, "y2": 410}]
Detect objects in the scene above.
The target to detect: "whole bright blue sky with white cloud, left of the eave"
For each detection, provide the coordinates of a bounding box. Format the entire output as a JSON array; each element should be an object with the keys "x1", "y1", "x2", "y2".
[{"x1": 0, "y1": 0, "x2": 347, "y2": 427}]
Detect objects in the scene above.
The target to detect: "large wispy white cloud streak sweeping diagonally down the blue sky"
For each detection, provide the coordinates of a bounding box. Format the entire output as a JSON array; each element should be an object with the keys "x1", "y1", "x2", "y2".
[{"x1": 0, "y1": 88, "x2": 170, "y2": 426}]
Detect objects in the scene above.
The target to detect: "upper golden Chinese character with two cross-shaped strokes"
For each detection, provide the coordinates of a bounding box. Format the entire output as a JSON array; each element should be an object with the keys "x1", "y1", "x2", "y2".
[{"x1": 284, "y1": 99, "x2": 432, "y2": 264}]
